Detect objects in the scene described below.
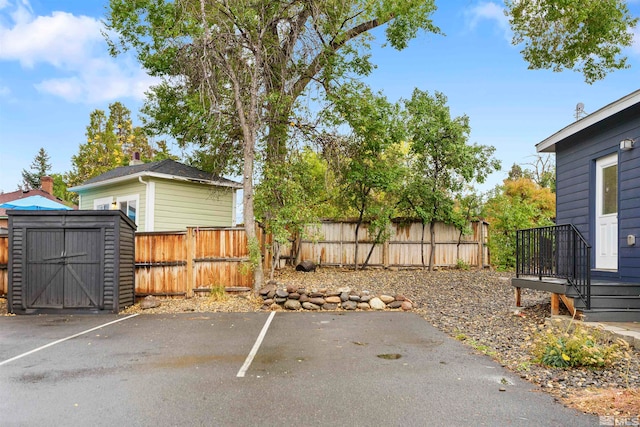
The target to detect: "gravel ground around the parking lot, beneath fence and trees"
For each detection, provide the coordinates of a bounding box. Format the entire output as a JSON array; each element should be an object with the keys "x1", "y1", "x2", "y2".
[{"x1": 0, "y1": 268, "x2": 640, "y2": 417}]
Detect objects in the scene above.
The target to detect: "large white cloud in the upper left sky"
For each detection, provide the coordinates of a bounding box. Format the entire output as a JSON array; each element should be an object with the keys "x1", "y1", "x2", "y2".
[{"x1": 0, "y1": 0, "x2": 155, "y2": 103}]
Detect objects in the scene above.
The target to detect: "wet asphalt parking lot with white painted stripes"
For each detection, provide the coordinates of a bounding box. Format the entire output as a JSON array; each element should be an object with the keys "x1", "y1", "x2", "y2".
[{"x1": 0, "y1": 312, "x2": 598, "y2": 426}]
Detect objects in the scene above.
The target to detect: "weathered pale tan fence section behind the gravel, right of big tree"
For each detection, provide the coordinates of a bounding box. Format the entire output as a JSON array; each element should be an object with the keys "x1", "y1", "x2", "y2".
[{"x1": 280, "y1": 221, "x2": 490, "y2": 267}]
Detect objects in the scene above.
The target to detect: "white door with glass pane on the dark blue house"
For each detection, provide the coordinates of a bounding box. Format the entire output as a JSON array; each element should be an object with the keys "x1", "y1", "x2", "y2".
[{"x1": 595, "y1": 154, "x2": 618, "y2": 270}]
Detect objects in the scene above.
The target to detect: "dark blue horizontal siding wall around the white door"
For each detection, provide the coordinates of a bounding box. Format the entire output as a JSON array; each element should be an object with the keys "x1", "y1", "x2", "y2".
[{"x1": 556, "y1": 106, "x2": 640, "y2": 281}]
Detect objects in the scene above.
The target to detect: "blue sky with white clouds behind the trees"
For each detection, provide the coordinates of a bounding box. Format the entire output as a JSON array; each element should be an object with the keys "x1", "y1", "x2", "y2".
[{"x1": 0, "y1": 0, "x2": 640, "y2": 196}]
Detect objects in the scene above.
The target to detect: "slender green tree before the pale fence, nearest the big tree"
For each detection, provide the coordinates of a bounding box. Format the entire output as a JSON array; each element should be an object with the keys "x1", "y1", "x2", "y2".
[{"x1": 324, "y1": 83, "x2": 404, "y2": 270}]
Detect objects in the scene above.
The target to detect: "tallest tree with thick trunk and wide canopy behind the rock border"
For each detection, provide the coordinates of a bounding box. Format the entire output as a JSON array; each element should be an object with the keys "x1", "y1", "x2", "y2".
[{"x1": 107, "y1": 0, "x2": 439, "y2": 286}]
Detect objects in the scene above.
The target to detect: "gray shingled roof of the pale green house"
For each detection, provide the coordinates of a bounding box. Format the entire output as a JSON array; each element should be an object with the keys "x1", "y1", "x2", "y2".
[{"x1": 69, "y1": 159, "x2": 242, "y2": 192}]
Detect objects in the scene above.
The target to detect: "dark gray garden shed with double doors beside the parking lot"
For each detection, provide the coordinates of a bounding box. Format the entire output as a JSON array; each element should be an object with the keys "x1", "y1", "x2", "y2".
[{"x1": 7, "y1": 210, "x2": 136, "y2": 314}]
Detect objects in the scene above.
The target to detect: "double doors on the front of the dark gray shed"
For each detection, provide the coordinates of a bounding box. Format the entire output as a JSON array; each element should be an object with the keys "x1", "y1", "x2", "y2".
[{"x1": 25, "y1": 229, "x2": 103, "y2": 308}]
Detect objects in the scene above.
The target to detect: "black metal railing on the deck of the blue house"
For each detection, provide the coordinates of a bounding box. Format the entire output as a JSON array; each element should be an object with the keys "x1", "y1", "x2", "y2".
[{"x1": 516, "y1": 224, "x2": 591, "y2": 310}]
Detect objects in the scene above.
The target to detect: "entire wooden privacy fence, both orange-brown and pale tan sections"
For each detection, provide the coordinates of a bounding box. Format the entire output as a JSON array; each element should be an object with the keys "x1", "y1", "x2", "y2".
[{"x1": 0, "y1": 221, "x2": 490, "y2": 296}]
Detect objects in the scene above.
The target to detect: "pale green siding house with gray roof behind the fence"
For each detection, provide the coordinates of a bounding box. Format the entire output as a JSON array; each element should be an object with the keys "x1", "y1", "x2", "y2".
[{"x1": 69, "y1": 160, "x2": 242, "y2": 231}]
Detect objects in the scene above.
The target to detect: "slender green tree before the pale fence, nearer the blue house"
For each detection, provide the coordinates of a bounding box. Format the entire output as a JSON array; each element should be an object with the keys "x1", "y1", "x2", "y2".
[{"x1": 403, "y1": 89, "x2": 500, "y2": 270}]
